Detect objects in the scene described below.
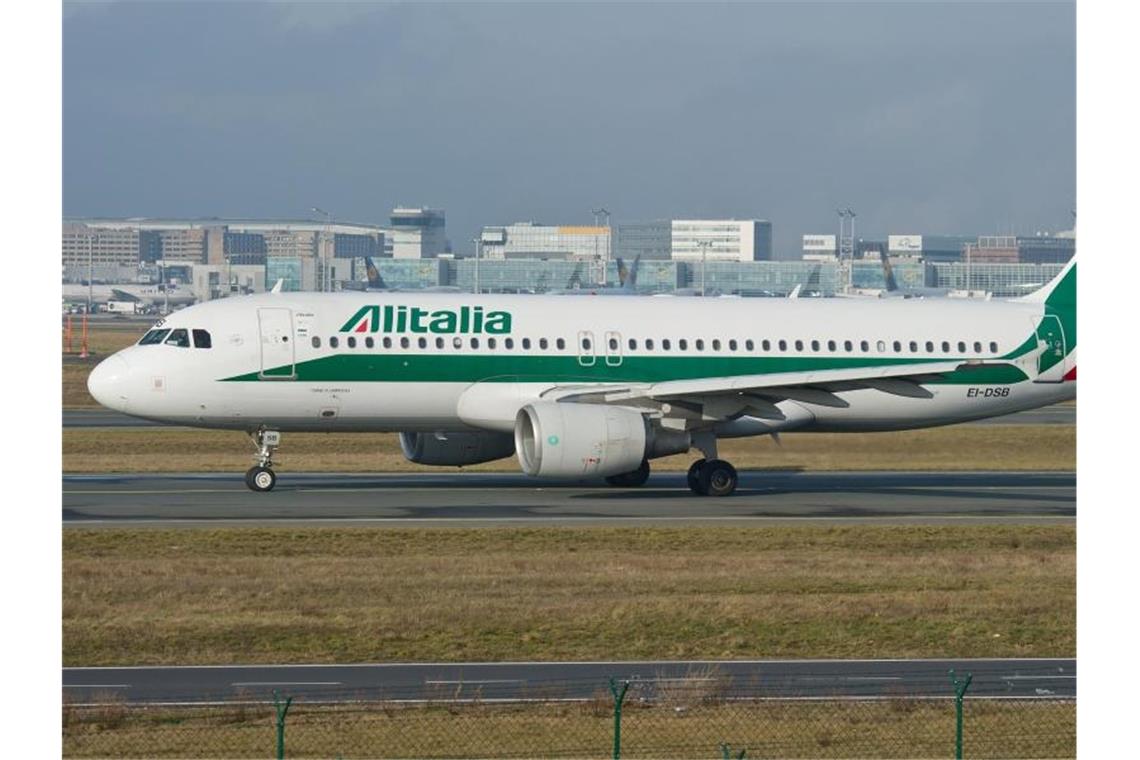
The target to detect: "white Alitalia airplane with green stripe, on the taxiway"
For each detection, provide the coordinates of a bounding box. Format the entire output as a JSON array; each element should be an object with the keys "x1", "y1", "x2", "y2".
[{"x1": 88, "y1": 262, "x2": 1076, "y2": 496}]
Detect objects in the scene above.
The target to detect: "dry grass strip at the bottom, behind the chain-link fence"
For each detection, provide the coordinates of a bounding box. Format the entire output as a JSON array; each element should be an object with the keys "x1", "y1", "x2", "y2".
[{"x1": 63, "y1": 697, "x2": 1076, "y2": 758}]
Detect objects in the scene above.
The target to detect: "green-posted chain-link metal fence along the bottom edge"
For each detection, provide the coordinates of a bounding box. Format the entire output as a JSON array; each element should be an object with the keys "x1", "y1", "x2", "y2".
[{"x1": 63, "y1": 671, "x2": 1076, "y2": 758}]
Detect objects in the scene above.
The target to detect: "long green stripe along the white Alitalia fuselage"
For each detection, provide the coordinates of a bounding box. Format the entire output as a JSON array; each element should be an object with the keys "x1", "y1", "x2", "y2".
[{"x1": 217, "y1": 353, "x2": 1026, "y2": 385}]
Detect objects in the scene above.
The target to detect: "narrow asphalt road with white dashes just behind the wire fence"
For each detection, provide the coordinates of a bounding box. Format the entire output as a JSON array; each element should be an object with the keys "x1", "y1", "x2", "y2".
[{"x1": 63, "y1": 660, "x2": 1076, "y2": 702}]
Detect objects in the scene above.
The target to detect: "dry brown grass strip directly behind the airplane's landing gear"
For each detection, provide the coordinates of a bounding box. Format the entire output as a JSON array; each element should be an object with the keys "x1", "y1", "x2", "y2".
[{"x1": 63, "y1": 425, "x2": 1076, "y2": 473}]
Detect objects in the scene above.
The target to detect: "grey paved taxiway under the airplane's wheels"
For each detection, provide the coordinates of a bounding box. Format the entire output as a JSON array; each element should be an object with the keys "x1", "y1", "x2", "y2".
[{"x1": 63, "y1": 471, "x2": 1076, "y2": 528}]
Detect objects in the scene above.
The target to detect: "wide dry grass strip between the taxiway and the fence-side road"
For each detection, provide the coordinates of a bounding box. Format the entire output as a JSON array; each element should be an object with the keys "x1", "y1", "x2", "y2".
[{"x1": 63, "y1": 525, "x2": 1076, "y2": 665}]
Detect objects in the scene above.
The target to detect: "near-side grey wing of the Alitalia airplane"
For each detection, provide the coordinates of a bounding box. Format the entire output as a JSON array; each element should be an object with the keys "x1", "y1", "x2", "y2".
[{"x1": 544, "y1": 361, "x2": 989, "y2": 419}]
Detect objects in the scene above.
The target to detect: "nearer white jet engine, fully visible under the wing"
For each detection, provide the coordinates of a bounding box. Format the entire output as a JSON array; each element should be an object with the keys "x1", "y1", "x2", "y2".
[{"x1": 514, "y1": 401, "x2": 690, "y2": 477}]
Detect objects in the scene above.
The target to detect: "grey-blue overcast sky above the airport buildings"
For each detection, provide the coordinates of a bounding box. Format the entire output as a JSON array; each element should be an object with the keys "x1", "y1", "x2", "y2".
[{"x1": 63, "y1": 2, "x2": 1076, "y2": 258}]
